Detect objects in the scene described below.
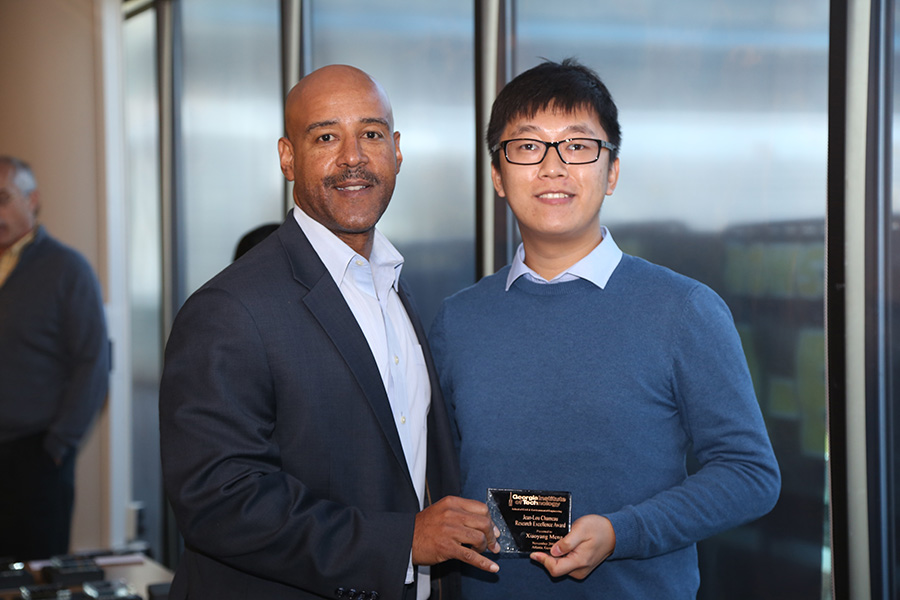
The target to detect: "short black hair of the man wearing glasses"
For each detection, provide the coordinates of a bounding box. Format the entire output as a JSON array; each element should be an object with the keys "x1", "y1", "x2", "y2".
[{"x1": 486, "y1": 58, "x2": 622, "y2": 166}]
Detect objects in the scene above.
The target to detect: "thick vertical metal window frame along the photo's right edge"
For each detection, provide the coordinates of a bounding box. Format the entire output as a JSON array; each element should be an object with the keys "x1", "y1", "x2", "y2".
[{"x1": 826, "y1": 0, "x2": 900, "y2": 600}]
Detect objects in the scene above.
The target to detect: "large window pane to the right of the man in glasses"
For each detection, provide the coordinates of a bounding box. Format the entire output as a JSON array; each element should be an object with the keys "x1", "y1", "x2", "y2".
[{"x1": 515, "y1": 0, "x2": 829, "y2": 599}]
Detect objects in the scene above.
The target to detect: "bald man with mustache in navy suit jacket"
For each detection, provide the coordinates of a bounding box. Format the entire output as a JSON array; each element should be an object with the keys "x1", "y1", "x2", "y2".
[{"x1": 160, "y1": 65, "x2": 497, "y2": 600}]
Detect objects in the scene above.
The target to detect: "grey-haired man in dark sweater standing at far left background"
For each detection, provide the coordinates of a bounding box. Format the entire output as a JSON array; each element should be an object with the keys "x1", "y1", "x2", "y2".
[{"x1": 0, "y1": 156, "x2": 110, "y2": 560}]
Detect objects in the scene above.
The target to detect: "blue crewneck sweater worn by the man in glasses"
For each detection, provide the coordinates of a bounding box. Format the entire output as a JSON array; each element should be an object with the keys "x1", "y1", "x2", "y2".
[{"x1": 431, "y1": 255, "x2": 780, "y2": 600}]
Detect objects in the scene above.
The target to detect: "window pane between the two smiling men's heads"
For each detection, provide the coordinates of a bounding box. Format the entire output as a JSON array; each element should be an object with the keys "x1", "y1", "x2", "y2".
[{"x1": 312, "y1": 0, "x2": 478, "y2": 329}]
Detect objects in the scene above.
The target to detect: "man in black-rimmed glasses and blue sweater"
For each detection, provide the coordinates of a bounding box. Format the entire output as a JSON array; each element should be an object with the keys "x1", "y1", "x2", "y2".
[{"x1": 431, "y1": 60, "x2": 781, "y2": 600}]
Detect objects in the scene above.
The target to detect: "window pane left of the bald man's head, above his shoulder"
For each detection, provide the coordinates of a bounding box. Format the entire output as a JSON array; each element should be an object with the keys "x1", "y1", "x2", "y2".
[{"x1": 179, "y1": 0, "x2": 284, "y2": 300}]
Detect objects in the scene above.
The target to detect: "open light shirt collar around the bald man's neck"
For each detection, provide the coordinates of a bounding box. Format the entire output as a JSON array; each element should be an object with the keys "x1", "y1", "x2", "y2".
[{"x1": 293, "y1": 206, "x2": 403, "y2": 291}]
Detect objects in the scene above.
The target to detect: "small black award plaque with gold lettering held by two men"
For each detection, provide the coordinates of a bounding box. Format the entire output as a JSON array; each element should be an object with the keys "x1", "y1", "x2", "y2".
[{"x1": 487, "y1": 488, "x2": 572, "y2": 556}]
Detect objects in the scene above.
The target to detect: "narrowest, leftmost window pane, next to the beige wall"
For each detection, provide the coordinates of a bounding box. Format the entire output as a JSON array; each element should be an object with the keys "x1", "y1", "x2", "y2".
[{"x1": 124, "y1": 10, "x2": 162, "y2": 556}]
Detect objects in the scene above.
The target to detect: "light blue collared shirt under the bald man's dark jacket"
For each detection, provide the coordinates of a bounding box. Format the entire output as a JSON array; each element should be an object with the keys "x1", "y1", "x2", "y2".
[{"x1": 294, "y1": 206, "x2": 431, "y2": 598}]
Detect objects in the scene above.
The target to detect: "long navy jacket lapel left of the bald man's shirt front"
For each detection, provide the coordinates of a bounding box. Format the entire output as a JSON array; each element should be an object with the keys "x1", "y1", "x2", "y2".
[{"x1": 277, "y1": 214, "x2": 418, "y2": 488}]
